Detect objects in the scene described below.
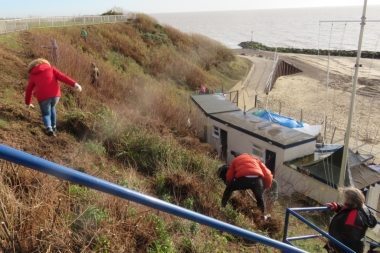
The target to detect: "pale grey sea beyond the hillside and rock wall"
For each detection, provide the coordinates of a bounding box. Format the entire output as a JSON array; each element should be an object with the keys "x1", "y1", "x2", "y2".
[{"x1": 149, "y1": 5, "x2": 380, "y2": 52}]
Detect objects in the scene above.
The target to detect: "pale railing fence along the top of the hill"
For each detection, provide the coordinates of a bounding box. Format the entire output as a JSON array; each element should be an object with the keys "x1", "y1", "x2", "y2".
[{"x1": 0, "y1": 13, "x2": 134, "y2": 34}]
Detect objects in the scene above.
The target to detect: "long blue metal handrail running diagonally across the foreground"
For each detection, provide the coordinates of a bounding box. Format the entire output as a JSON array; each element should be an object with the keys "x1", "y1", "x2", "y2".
[{"x1": 0, "y1": 144, "x2": 306, "y2": 253}]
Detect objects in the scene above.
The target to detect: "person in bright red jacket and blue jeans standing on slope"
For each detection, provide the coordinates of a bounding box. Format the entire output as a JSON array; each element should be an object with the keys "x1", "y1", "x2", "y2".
[{"x1": 25, "y1": 58, "x2": 82, "y2": 136}]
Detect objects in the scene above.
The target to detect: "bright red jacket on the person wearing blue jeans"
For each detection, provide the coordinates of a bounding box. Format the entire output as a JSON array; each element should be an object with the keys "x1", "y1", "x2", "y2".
[{"x1": 25, "y1": 63, "x2": 76, "y2": 105}]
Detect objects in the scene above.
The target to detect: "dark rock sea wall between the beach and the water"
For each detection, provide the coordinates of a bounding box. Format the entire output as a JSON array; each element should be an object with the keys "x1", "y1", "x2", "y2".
[{"x1": 239, "y1": 41, "x2": 380, "y2": 59}]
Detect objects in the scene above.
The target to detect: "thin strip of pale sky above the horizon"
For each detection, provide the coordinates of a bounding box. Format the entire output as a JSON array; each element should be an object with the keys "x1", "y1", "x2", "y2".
[{"x1": 0, "y1": 0, "x2": 380, "y2": 18}]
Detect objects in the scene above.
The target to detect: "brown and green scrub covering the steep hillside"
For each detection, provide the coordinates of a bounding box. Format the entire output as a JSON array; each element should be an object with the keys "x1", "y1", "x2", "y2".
[{"x1": 0, "y1": 14, "x2": 330, "y2": 252}]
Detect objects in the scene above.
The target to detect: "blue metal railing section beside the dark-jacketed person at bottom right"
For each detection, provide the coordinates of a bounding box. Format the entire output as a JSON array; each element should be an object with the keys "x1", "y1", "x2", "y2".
[{"x1": 283, "y1": 206, "x2": 355, "y2": 253}]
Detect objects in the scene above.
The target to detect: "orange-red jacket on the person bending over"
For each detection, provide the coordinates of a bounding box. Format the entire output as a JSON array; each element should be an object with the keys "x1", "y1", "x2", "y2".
[{"x1": 227, "y1": 154, "x2": 273, "y2": 189}]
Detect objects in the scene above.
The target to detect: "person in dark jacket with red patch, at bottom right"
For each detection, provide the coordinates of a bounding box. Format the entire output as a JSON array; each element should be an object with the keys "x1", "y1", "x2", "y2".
[{"x1": 325, "y1": 187, "x2": 377, "y2": 253}]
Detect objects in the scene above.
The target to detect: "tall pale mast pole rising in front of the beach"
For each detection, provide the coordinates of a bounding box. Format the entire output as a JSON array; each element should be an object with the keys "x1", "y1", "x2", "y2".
[{"x1": 339, "y1": 0, "x2": 367, "y2": 187}]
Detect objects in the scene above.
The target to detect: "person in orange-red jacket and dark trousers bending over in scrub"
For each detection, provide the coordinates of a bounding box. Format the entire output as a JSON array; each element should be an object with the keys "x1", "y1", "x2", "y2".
[{"x1": 222, "y1": 151, "x2": 273, "y2": 214}]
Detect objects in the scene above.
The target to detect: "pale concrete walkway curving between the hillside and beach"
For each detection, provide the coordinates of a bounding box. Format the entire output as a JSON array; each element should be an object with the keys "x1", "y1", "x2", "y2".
[{"x1": 228, "y1": 55, "x2": 273, "y2": 110}]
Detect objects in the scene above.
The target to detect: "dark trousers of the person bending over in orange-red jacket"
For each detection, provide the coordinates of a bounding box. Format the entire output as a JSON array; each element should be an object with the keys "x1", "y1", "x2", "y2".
[{"x1": 222, "y1": 177, "x2": 265, "y2": 213}]
